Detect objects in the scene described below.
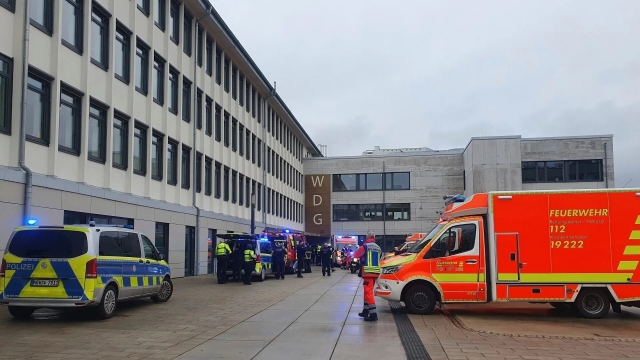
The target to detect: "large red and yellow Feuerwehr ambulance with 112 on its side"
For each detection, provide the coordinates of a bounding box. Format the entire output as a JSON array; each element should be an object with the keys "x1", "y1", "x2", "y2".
[{"x1": 376, "y1": 189, "x2": 640, "y2": 319}]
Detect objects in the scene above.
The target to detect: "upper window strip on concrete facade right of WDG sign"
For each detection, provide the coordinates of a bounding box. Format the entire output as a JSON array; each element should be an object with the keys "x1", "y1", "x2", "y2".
[{"x1": 333, "y1": 172, "x2": 411, "y2": 191}]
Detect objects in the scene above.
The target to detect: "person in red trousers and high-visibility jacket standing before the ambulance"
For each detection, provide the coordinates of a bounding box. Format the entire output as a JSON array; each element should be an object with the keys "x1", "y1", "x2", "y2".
[{"x1": 353, "y1": 231, "x2": 382, "y2": 321}]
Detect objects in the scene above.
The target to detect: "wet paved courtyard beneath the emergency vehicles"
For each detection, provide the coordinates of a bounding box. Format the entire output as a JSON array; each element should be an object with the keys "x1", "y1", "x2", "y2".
[{"x1": 0, "y1": 267, "x2": 640, "y2": 360}]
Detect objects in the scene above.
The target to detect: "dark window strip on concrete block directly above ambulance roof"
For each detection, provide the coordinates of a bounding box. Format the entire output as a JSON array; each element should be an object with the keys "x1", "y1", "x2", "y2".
[{"x1": 522, "y1": 159, "x2": 604, "y2": 183}]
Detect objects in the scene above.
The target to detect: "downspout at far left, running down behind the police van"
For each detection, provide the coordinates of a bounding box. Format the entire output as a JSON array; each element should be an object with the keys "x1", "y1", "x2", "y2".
[{"x1": 18, "y1": 0, "x2": 33, "y2": 225}]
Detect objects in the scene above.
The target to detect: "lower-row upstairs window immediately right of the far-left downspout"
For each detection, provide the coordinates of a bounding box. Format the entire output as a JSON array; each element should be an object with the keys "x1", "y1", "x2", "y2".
[{"x1": 26, "y1": 71, "x2": 51, "y2": 146}]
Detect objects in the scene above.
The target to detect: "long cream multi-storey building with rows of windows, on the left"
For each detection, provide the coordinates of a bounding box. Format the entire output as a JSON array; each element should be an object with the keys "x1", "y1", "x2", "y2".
[{"x1": 0, "y1": 0, "x2": 320, "y2": 276}]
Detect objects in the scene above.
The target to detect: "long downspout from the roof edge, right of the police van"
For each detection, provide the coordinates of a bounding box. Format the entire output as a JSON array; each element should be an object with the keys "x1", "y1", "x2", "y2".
[{"x1": 191, "y1": 4, "x2": 213, "y2": 276}]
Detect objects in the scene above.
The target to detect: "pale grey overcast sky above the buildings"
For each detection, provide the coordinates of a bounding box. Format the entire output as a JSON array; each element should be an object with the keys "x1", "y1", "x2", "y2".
[{"x1": 211, "y1": 0, "x2": 640, "y2": 187}]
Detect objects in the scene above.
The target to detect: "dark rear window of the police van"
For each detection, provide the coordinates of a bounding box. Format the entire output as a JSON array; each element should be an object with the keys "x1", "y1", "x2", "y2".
[{"x1": 7, "y1": 229, "x2": 87, "y2": 259}]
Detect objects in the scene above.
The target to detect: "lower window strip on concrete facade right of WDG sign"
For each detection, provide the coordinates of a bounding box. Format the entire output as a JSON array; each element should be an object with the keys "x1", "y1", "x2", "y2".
[{"x1": 333, "y1": 203, "x2": 411, "y2": 221}]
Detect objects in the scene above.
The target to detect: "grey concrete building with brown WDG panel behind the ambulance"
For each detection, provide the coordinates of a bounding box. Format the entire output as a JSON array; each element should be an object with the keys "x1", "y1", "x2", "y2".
[{"x1": 304, "y1": 135, "x2": 614, "y2": 250}]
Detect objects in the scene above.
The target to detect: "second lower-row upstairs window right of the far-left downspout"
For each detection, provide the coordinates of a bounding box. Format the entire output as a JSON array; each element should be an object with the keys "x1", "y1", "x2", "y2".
[{"x1": 58, "y1": 85, "x2": 82, "y2": 155}]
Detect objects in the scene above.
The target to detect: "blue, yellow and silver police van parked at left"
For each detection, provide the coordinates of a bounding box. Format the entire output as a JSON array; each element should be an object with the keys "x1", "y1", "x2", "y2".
[{"x1": 0, "y1": 222, "x2": 173, "y2": 319}]
